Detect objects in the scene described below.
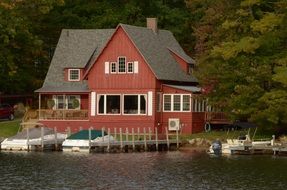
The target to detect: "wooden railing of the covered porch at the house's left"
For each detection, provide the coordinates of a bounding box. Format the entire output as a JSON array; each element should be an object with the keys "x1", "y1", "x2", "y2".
[{"x1": 39, "y1": 109, "x2": 88, "y2": 120}]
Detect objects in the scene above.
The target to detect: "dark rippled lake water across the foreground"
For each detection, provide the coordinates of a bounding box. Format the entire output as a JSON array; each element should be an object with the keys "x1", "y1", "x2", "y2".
[{"x1": 0, "y1": 150, "x2": 287, "y2": 190}]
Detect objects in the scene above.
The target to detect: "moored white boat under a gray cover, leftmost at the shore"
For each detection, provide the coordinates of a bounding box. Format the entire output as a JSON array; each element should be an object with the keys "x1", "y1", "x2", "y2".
[{"x1": 1, "y1": 127, "x2": 67, "y2": 151}]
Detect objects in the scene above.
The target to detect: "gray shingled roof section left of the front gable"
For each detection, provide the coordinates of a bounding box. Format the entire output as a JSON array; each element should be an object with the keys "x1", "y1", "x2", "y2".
[{"x1": 36, "y1": 29, "x2": 115, "y2": 92}]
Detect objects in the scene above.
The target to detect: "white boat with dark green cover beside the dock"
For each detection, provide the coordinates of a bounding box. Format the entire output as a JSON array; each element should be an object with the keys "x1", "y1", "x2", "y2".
[{"x1": 62, "y1": 130, "x2": 115, "y2": 152}]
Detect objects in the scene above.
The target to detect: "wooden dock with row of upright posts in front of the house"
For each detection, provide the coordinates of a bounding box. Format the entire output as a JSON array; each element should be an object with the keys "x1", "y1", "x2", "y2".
[{"x1": 64, "y1": 128, "x2": 181, "y2": 152}]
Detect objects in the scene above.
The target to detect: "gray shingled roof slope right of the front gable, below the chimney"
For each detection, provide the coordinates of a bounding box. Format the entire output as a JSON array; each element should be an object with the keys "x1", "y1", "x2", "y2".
[{"x1": 120, "y1": 24, "x2": 197, "y2": 82}]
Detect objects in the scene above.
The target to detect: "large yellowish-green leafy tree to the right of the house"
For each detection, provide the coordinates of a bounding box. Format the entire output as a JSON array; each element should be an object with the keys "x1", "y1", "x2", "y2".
[{"x1": 189, "y1": 0, "x2": 287, "y2": 131}]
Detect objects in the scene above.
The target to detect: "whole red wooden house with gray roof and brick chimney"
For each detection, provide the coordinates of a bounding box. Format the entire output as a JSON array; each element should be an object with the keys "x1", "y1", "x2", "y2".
[{"x1": 36, "y1": 18, "x2": 216, "y2": 133}]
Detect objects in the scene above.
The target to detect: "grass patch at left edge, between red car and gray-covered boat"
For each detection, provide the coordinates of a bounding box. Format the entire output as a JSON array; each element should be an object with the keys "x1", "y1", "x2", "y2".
[{"x1": 0, "y1": 119, "x2": 21, "y2": 137}]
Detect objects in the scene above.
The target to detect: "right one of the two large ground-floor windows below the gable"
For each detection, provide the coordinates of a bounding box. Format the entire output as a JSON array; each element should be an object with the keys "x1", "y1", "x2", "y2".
[{"x1": 123, "y1": 94, "x2": 147, "y2": 115}]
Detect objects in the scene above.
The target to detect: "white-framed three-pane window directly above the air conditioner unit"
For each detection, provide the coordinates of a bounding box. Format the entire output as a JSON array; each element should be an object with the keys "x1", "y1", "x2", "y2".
[{"x1": 163, "y1": 94, "x2": 190, "y2": 112}]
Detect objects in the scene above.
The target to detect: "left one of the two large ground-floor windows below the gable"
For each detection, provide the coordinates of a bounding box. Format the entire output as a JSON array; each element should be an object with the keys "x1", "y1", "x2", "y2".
[{"x1": 98, "y1": 94, "x2": 121, "y2": 115}]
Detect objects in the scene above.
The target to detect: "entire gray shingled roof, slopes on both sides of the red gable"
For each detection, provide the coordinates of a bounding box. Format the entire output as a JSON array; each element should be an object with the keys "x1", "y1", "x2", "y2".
[{"x1": 36, "y1": 24, "x2": 197, "y2": 92}]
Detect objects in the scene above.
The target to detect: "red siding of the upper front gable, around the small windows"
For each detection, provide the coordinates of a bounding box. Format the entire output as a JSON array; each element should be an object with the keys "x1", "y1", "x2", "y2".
[{"x1": 88, "y1": 27, "x2": 156, "y2": 90}]
